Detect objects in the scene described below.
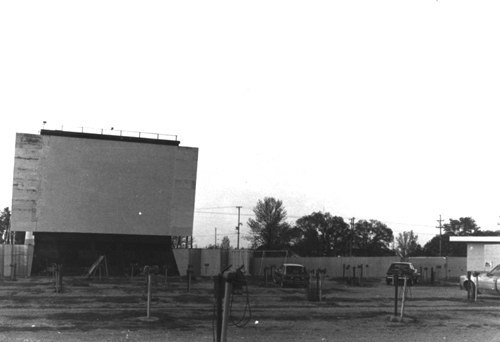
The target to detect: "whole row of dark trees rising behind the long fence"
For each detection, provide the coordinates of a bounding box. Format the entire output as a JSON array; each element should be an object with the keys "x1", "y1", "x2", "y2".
[{"x1": 239, "y1": 197, "x2": 500, "y2": 258}]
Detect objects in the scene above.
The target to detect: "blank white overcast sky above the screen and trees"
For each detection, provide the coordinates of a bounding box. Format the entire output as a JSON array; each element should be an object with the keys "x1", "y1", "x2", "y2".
[{"x1": 0, "y1": 0, "x2": 500, "y2": 250}]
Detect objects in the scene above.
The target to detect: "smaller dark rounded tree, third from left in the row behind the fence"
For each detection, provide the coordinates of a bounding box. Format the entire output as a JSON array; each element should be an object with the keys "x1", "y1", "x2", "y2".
[{"x1": 353, "y1": 220, "x2": 394, "y2": 256}]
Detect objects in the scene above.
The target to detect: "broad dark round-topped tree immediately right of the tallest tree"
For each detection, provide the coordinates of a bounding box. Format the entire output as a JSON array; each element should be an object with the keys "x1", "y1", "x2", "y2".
[{"x1": 294, "y1": 212, "x2": 349, "y2": 256}]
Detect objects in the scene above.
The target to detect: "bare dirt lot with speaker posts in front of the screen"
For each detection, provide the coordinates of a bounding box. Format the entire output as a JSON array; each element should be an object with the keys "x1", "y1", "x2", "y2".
[{"x1": 0, "y1": 278, "x2": 500, "y2": 342}]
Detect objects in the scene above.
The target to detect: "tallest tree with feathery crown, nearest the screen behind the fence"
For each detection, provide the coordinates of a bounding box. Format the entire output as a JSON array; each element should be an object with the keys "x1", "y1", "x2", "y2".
[{"x1": 247, "y1": 197, "x2": 294, "y2": 249}]
